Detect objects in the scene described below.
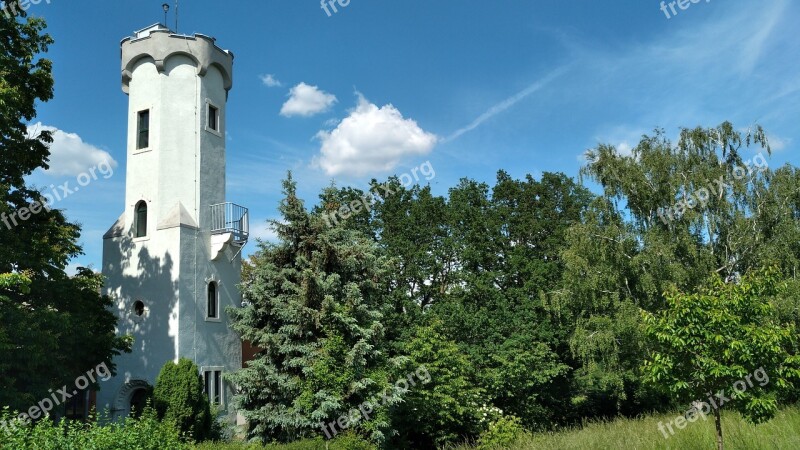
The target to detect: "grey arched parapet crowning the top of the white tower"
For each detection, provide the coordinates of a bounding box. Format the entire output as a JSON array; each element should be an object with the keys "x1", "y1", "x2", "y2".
[{"x1": 121, "y1": 25, "x2": 233, "y2": 94}]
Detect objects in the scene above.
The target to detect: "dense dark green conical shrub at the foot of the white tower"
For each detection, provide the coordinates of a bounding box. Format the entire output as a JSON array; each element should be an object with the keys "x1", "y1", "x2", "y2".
[{"x1": 153, "y1": 358, "x2": 213, "y2": 441}]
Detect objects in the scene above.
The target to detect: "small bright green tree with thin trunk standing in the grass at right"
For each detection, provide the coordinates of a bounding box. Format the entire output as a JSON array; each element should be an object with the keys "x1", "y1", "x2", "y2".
[{"x1": 644, "y1": 270, "x2": 800, "y2": 450}]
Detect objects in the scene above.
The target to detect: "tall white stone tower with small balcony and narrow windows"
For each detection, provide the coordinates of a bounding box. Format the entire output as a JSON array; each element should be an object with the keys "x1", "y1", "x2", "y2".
[{"x1": 97, "y1": 25, "x2": 248, "y2": 418}]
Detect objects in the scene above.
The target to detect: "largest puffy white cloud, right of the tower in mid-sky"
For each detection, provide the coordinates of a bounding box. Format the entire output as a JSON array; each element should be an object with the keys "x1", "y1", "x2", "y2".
[{"x1": 314, "y1": 94, "x2": 438, "y2": 176}]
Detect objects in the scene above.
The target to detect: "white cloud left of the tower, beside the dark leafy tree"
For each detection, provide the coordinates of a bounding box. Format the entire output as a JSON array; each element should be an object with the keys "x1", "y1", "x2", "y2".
[{"x1": 28, "y1": 122, "x2": 117, "y2": 176}]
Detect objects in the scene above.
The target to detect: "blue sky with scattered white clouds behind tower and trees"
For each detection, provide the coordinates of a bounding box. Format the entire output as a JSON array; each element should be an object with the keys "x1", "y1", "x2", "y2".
[{"x1": 17, "y1": 0, "x2": 800, "y2": 269}]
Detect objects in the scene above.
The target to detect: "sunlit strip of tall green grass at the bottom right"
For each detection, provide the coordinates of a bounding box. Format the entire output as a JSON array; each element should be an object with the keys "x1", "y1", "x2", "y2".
[{"x1": 458, "y1": 407, "x2": 800, "y2": 450}]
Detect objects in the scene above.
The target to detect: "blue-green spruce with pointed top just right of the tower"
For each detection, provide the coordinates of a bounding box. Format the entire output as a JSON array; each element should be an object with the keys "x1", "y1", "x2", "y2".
[{"x1": 228, "y1": 174, "x2": 400, "y2": 441}]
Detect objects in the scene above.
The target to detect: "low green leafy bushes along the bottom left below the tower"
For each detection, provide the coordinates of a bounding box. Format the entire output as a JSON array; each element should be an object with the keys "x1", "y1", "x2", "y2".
[{"x1": 0, "y1": 408, "x2": 188, "y2": 450}]
